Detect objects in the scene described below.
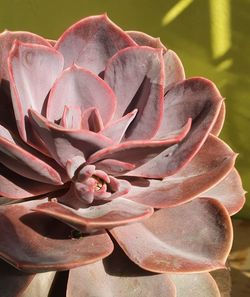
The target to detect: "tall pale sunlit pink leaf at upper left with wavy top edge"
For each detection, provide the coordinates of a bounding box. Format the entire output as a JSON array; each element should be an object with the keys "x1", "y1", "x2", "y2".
[{"x1": 8, "y1": 41, "x2": 63, "y2": 140}]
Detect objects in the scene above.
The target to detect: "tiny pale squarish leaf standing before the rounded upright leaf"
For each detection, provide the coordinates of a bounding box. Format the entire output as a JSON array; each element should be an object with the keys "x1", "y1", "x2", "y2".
[{"x1": 60, "y1": 105, "x2": 82, "y2": 130}]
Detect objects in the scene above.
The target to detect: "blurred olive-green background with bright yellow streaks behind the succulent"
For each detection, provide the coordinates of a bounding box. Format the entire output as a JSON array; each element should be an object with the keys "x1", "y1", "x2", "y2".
[{"x1": 0, "y1": 0, "x2": 250, "y2": 218}]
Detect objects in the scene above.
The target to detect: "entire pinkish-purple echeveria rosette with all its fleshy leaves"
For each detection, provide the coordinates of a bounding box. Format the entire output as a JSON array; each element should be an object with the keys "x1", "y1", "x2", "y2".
[{"x1": 0, "y1": 15, "x2": 244, "y2": 297}]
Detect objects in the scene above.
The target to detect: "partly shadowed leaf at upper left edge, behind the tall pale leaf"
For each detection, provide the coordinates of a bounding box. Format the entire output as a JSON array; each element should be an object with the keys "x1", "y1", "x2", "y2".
[{"x1": 0, "y1": 30, "x2": 50, "y2": 131}]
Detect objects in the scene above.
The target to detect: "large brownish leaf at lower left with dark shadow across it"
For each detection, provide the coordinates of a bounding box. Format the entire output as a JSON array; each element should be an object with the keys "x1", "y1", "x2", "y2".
[{"x1": 0, "y1": 199, "x2": 113, "y2": 272}]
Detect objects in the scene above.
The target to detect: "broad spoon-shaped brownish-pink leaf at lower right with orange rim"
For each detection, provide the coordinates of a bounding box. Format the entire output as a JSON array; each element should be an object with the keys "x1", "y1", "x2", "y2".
[{"x1": 111, "y1": 198, "x2": 232, "y2": 272}]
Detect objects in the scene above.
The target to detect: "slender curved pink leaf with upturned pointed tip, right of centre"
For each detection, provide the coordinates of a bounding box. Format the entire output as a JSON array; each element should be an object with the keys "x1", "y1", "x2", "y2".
[{"x1": 88, "y1": 119, "x2": 191, "y2": 169}]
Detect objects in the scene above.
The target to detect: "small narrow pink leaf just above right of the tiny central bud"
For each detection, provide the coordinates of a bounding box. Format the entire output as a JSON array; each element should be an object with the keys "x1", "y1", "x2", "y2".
[{"x1": 95, "y1": 159, "x2": 135, "y2": 176}]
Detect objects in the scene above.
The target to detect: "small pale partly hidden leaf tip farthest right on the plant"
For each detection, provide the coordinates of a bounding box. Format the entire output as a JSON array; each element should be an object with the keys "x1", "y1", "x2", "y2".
[{"x1": 199, "y1": 168, "x2": 246, "y2": 215}]
